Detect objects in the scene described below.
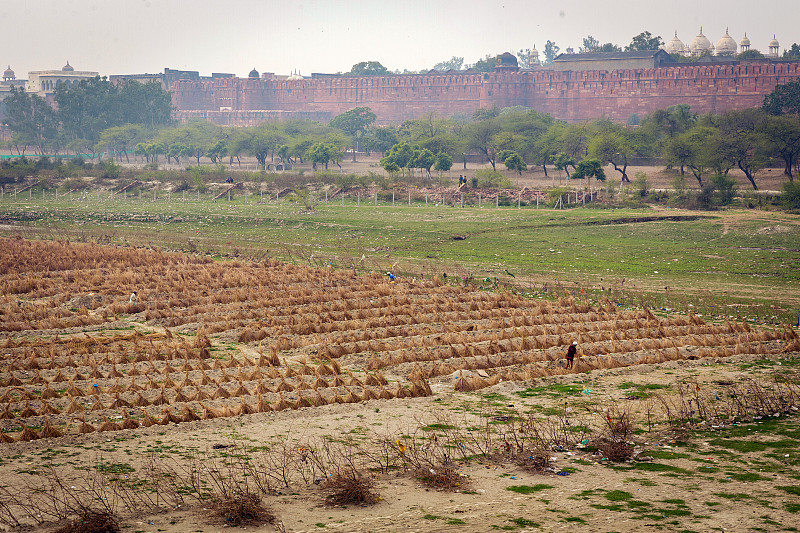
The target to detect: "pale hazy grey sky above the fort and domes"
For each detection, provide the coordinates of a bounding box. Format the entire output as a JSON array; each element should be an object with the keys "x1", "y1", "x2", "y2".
[{"x1": 0, "y1": 0, "x2": 800, "y2": 78}]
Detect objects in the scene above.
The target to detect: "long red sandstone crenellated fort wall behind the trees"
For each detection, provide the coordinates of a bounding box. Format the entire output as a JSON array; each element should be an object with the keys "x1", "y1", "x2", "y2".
[{"x1": 173, "y1": 62, "x2": 800, "y2": 125}]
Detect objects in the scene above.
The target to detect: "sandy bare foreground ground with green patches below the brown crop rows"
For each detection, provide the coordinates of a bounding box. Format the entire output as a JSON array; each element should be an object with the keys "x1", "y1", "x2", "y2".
[{"x1": 0, "y1": 354, "x2": 800, "y2": 533}]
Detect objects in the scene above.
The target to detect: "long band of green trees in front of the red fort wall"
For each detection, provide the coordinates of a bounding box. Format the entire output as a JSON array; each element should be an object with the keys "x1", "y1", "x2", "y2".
[{"x1": 4, "y1": 78, "x2": 800, "y2": 189}]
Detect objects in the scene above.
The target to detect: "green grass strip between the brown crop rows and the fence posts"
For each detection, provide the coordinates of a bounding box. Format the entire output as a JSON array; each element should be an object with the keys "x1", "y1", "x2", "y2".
[{"x1": 0, "y1": 195, "x2": 800, "y2": 324}]
